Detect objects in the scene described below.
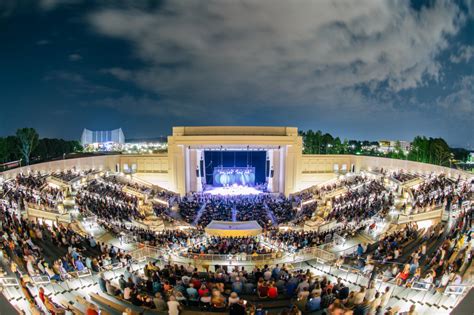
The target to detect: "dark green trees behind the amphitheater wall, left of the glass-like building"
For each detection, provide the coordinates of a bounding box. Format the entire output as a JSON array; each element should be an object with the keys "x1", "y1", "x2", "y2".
[{"x1": 0, "y1": 128, "x2": 82, "y2": 165}]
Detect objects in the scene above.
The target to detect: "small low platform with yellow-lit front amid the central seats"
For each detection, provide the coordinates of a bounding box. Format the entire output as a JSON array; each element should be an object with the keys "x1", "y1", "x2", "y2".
[{"x1": 204, "y1": 220, "x2": 262, "y2": 237}]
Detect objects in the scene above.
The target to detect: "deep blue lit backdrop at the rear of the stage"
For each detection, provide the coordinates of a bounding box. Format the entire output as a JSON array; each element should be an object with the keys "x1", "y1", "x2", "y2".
[{"x1": 204, "y1": 151, "x2": 266, "y2": 186}]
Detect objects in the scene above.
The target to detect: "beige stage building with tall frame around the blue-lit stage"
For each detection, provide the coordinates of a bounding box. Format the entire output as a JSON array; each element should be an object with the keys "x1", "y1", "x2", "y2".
[{"x1": 168, "y1": 127, "x2": 302, "y2": 195}]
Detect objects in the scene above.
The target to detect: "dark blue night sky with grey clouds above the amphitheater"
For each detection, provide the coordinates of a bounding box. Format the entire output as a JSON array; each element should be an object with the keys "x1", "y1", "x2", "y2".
[{"x1": 0, "y1": 0, "x2": 474, "y2": 148}]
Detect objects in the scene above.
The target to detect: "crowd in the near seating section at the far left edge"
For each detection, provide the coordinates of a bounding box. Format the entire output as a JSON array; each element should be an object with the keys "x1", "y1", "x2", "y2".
[{"x1": 0, "y1": 194, "x2": 136, "y2": 314}]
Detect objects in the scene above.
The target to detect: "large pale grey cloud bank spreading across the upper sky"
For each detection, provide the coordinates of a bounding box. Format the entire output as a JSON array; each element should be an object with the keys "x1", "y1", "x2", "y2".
[{"x1": 89, "y1": 0, "x2": 465, "y2": 116}]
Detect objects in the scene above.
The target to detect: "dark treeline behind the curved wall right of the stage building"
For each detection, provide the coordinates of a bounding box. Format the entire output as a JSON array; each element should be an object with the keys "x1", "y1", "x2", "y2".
[{"x1": 300, "y1": 130, "x2": 469, "y2": 166}]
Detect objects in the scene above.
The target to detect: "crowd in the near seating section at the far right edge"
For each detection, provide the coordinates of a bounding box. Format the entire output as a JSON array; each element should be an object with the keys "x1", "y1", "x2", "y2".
[{"x1": 344, "y1": 209, "x2": 474, "y2": 298}]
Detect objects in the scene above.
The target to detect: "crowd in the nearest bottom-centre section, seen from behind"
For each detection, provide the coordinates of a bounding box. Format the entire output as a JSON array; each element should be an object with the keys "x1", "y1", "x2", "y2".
[{"x1": 95, "y1": 262, "x2": 415, "y2": 315}]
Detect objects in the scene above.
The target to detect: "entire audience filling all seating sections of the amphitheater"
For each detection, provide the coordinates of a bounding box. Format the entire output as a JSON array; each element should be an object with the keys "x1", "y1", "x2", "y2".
[{"x1": 0, "y1": 167, "x2": 474, "y2": 315}]
